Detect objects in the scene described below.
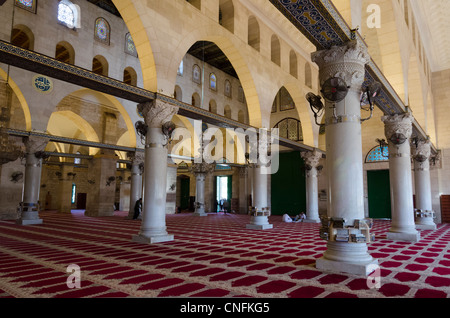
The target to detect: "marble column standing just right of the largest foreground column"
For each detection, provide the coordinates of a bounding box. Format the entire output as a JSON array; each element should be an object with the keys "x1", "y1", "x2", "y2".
[{"x1": 382, "y1": 113, "x2": 420, "y2": 242}]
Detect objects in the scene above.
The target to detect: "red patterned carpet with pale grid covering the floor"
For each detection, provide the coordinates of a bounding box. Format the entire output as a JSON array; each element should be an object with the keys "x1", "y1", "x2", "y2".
[{"x1": 0, "y1": 212, "x2": 450, "y2": 298}]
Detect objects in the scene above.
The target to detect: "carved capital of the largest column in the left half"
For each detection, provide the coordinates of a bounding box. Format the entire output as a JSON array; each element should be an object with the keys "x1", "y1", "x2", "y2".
[{"x1": 137, "y1": 99, "x2": 179, "y2": 128}]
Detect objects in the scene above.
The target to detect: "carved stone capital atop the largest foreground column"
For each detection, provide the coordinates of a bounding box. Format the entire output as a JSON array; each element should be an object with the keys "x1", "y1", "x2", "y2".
[{"x1": 311, "y1": 40, "x2": 370, "y2": 89}]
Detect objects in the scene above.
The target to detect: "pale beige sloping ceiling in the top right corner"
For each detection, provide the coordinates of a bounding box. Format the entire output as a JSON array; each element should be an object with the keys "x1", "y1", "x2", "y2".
[{"x1": 411, "y1": 0, "x2": 450, "y2": 72}]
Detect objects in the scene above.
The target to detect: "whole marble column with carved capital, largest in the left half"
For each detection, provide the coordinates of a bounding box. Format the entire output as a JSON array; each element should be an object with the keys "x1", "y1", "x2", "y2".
[{"x1": 133, "y1": 100, "x2": 178, "y2": 244}]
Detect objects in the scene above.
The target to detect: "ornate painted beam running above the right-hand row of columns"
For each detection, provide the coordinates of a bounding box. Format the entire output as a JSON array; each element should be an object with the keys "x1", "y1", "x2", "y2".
[{"x1": 270, "y1": 0, "x2": 432, "y2": 151}]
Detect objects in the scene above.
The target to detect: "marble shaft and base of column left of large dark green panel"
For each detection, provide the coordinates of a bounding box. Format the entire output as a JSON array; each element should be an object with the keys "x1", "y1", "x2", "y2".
[{"x1": 246, "y1": 164, "x2": 273, "y2": 230}]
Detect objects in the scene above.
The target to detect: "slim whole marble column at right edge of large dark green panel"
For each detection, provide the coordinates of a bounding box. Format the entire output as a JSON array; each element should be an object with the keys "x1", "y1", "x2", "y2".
[{"x1": 302, "y1": 150, "x2": 322, "y2": 223}]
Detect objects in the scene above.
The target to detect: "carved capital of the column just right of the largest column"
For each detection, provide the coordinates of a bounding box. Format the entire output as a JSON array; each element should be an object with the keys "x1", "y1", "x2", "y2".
[{"x1": 381, "y1": 113, "x2": 414, "y2": 145}]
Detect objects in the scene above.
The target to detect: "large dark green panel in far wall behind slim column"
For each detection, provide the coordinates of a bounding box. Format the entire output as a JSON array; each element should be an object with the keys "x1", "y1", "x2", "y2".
[{"x1": 271, "y1": 151, "x2": 306, "y2": 215}]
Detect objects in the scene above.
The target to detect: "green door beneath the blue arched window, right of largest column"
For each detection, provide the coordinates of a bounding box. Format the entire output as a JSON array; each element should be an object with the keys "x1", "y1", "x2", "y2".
[{"x1": 367, "y1": 170, "x2": 391, "y2": 219}]
